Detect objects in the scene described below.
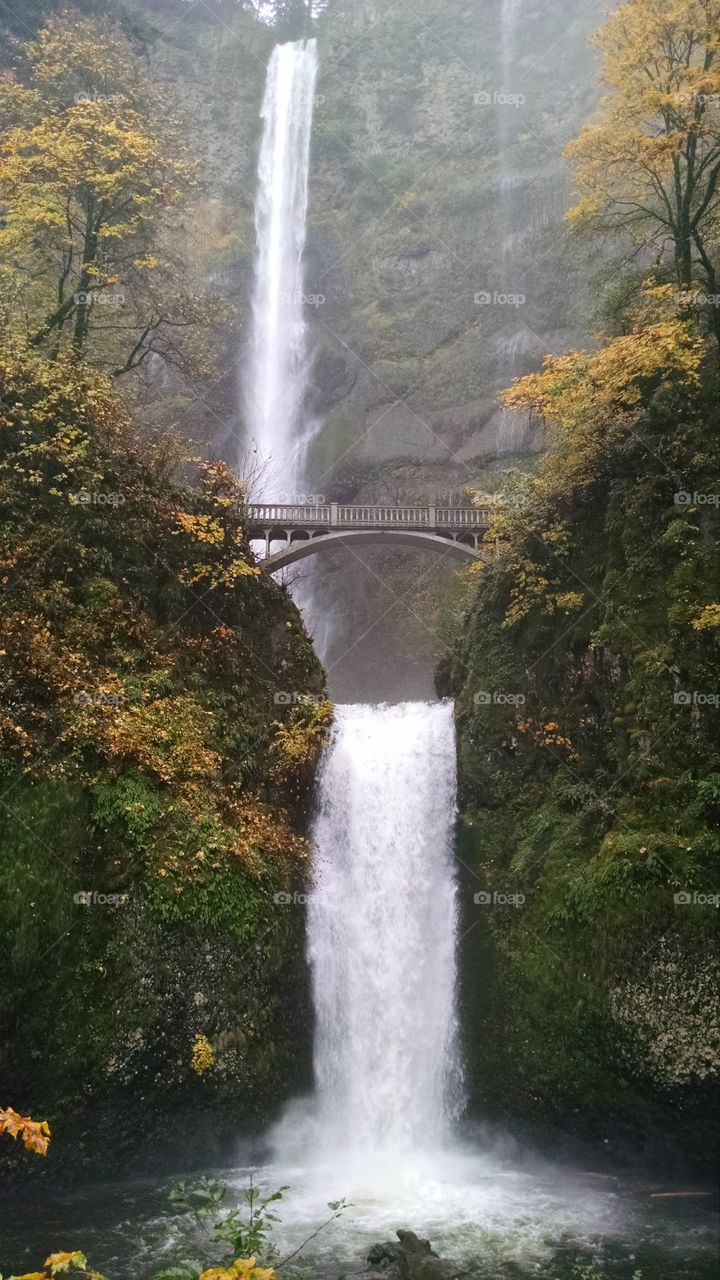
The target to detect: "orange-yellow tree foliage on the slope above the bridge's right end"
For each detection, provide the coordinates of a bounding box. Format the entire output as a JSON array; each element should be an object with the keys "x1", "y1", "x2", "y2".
[{"x1": 488, "y1": 285, "x2": 705, "y2": 628}]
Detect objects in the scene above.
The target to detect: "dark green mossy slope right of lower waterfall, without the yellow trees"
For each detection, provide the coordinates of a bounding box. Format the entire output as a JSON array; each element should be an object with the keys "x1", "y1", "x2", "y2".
[{"x1": 441, "y1": 327, "x2": 720, "y2": 1161}]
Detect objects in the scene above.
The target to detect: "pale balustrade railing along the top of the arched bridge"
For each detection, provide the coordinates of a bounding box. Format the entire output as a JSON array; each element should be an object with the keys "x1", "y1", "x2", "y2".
[{"x1": 245, "y1": 503, "x2": 489, "y2": 530}]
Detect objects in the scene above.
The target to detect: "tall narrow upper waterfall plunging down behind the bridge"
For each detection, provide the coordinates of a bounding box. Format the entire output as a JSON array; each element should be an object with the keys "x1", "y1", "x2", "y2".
[{"x1": 245, "y1": 40, "x2": 318, "y2": 502}]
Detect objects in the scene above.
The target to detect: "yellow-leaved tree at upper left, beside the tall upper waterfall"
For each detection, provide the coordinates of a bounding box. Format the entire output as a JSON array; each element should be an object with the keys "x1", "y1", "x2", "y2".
[{"x1": 0, "y1": 14, "x2": 215, "y2": 374}]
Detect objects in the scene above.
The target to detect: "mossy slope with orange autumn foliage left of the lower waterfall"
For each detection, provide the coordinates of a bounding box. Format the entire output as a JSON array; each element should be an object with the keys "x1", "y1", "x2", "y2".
[{"x1": 0, "y1": 349, "x2": 329, "y2": 1171}]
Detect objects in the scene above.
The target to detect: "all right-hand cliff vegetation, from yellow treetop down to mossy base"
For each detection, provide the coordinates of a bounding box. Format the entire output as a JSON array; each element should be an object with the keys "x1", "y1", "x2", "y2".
[{"x1": 442, "y1": 0, "x2": 720, "y2": 1156}]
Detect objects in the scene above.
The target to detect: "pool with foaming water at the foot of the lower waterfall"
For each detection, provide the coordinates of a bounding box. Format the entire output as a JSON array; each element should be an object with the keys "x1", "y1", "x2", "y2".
[{"x1": 3, "y1": 1149, "x2": 717, "y2": 1280}]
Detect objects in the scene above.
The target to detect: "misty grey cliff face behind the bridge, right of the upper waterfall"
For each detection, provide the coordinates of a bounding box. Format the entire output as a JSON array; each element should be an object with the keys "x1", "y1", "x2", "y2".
[{"x1": 289, "y1": 0, "x2": 602, "y2": 699}]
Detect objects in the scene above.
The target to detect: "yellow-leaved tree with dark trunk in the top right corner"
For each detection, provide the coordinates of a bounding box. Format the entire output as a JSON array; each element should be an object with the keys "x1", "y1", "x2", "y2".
[{"x1": 566, "y1": 0, "x2": 720, "y2": 334}]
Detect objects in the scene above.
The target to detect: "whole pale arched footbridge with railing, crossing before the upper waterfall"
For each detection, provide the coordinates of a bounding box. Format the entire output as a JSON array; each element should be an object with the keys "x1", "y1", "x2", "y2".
[{"x1": 245, "y1": 502, "x2": 489, "y2": 573}]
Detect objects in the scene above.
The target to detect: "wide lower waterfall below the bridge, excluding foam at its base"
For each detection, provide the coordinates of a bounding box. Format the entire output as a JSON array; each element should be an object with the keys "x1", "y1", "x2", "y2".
[{"x1": 307, "y1": 703, "x2": 460, "y2": 1155}]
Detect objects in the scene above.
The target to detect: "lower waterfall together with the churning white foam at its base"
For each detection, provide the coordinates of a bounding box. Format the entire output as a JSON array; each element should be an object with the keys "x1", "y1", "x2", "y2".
[{"x1": 265, "y1": 703, "x2": 632, "y2": 1276}]
